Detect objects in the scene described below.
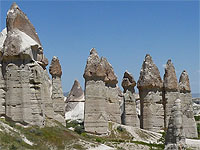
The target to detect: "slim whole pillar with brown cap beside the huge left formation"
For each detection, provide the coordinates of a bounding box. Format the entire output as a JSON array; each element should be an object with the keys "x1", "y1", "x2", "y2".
[{"x1": 49, "y1": 56, "x2": 65, "y2": 125}]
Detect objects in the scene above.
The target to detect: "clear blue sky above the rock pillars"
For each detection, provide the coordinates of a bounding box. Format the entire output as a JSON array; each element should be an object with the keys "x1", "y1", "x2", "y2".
[{"x1": 0, "y1": 1, "x2": 200, "y2": 93}]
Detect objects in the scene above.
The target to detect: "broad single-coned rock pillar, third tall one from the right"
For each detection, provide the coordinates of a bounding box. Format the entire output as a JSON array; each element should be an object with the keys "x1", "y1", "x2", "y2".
[{"x1": 137, "y1": 54, "x2": 164, "y2": 132}]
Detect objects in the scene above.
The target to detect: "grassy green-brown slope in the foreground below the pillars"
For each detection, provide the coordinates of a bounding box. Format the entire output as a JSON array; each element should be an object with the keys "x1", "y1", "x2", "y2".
[{"x1": 0, "y1": 120, "x2": 163, "y2": 150}]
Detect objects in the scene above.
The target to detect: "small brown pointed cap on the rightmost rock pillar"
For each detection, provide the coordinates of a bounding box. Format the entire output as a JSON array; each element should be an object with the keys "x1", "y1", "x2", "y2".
[{"x1": 179, "y1": 70, "x2": 191, "y2": 92}]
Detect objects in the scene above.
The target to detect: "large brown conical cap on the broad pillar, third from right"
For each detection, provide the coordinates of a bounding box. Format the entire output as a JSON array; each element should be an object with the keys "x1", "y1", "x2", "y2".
[{"x1": 137, "y1": 54, "x2": 162, "y2": 89}]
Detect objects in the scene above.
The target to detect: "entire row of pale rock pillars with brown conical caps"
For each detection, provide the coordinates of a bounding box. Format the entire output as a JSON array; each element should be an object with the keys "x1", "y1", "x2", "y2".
[{"x1": 0, "y1": 3, "x2": 198, "y2": 149}]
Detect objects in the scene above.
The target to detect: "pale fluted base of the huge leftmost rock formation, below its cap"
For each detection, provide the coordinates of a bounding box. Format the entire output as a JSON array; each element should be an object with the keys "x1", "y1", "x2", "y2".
[{"x1": 5, "y1": 62, "x2": 54, "y2": 126}]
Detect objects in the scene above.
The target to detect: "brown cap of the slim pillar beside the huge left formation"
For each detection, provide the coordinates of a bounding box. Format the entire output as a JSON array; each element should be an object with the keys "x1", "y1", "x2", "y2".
[{"x1": 49, "y1": 56, "x2": 62, "y2": 77}]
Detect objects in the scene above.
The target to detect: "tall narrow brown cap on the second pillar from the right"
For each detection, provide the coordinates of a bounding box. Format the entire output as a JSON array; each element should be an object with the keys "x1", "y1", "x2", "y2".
[{"x1": 163, "y1": 59, "x2": 178, "y2": 91}]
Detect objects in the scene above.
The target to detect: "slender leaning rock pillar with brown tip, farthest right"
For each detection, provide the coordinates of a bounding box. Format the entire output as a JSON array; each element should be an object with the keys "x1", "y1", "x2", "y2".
[{"x1": 179, "y1": 70, "x2": 198, "y2": 138}]
